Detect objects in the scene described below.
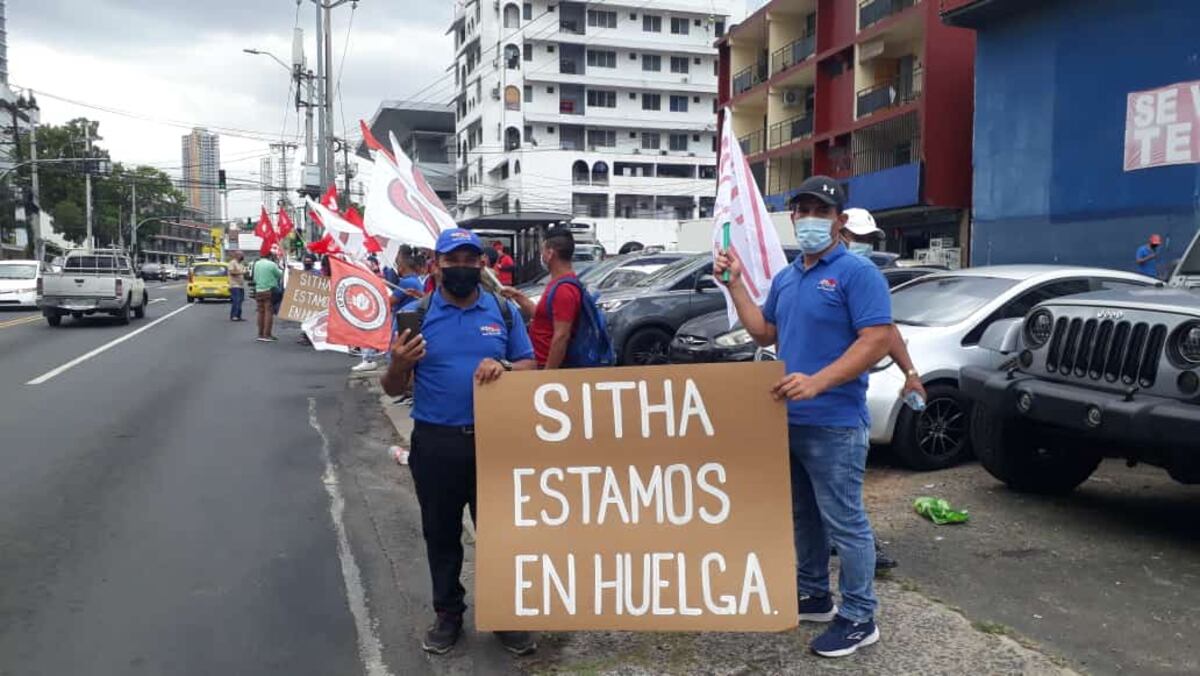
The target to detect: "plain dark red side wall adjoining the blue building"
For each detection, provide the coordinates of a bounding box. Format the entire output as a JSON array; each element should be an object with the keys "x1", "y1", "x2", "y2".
[{"x1": 920, "y1": 2, "x2": 976, "y2": 208}]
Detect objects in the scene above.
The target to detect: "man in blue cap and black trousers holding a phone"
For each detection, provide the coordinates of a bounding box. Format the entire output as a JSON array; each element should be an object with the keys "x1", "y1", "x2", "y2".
[{"x1": 382, "y1": 228, "x2": 536, "y2": 654}]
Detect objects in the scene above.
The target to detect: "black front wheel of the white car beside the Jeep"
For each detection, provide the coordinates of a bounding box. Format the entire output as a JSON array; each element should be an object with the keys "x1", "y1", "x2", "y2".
[{"x1": 893, "y1": 384, "x2": 971, "y2": 472}]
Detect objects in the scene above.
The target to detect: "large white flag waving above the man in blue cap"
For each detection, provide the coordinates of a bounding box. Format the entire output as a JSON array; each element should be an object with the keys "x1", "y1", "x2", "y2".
[{"x1": 362, "y1": 122, "x2": 457, "y2": 251}]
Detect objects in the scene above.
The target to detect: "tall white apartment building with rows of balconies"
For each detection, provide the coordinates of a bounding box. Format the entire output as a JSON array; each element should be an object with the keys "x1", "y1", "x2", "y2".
[{"x1": 450, "y1": 0, "x2": 736, "y2": 251}]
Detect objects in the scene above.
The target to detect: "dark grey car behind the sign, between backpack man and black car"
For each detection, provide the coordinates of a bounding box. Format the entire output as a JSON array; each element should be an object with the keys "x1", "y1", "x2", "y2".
[{"x1": 599, "y1": 253, "x2": 725, "y2": 365}]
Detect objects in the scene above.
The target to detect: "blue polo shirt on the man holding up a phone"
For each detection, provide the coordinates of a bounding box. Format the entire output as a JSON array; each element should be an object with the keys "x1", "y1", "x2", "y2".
[{"x1": 413, "y1": 287, "x2": 533, "y2": 425}]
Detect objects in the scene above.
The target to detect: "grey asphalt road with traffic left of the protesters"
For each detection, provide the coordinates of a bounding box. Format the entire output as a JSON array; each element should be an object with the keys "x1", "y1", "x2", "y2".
[{"x1": 0, "y1": 282, "x2": 362, "y2": 676}]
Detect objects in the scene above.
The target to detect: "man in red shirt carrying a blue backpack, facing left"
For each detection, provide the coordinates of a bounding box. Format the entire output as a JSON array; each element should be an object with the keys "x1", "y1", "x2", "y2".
[{"x1": 502, "y1": 227, "x2": 583, "y2": 369}]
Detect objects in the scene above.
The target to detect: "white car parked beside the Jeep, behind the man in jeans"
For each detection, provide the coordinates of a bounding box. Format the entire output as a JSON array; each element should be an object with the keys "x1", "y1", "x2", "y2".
[{"x1": 757, "y1": 265, "x2": 1158, "y2": 469}]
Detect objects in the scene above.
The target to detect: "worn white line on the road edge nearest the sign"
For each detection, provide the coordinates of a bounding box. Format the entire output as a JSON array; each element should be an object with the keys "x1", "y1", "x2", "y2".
[{"x1": 307, "y1": 398, "x2": 391, "y2": 676}]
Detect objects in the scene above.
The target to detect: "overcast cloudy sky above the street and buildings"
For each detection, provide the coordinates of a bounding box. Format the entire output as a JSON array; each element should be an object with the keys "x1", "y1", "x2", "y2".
[{"x1": 7, "y1": 0, "x2": 748, "y2": 217}]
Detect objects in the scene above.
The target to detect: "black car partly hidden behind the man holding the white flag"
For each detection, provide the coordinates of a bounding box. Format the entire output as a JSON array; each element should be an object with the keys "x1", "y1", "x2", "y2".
[{"x1": 670, "y1": 265, "x2": 937, "y2": 364}]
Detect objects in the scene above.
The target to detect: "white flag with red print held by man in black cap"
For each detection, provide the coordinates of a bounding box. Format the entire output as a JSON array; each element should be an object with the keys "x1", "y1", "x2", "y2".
[{"x1": 713, "y1": 115, "x2": 787, "y2": 327}]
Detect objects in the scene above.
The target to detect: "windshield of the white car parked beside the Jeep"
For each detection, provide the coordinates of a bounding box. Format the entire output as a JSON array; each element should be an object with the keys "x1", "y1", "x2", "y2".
[{"x1": 892, "y1": 275, "x2": 1016, "y2": 327}]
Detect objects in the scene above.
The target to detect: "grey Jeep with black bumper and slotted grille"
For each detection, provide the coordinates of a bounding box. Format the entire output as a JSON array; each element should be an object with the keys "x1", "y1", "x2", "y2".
[{"x1": 961, "y1": 288, "x2": 1200, "y2": 493}]
